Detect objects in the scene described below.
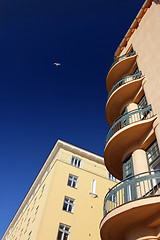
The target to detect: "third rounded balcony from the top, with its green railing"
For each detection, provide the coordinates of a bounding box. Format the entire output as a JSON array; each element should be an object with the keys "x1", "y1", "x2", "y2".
[{"x1": 104, "y1": 105, "x2": 156, "y2": 180}]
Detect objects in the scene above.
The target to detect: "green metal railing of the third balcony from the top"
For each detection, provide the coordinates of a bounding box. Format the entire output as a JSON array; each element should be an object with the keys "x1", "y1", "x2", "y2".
[{"x1": 106, "y1": 105, "x2": 153, "y2": 143}]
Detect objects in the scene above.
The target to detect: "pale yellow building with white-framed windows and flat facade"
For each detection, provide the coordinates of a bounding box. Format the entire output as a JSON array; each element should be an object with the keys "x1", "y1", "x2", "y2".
[{"x1": 2, "y1": 140, "x2": 116, "y2": 240}]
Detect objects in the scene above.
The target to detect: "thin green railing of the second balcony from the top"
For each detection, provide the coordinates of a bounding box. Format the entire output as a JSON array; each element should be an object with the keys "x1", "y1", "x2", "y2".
[{"x1": 108, "y1": 72, "x2": 142, "y2": 98}]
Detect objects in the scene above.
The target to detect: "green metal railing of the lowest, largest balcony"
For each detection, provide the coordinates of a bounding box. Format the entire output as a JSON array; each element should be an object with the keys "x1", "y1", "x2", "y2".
[{"x1": 103, "y1": 170, "x2": 160, "y2": 216}]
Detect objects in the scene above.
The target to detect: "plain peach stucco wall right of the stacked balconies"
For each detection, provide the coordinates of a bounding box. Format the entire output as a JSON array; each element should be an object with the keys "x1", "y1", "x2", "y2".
[{"x1": 121, "y1": 1, "x2": 160, "y2": 146}]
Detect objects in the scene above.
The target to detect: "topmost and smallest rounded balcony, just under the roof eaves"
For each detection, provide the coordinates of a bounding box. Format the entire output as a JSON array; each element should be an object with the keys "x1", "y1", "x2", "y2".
[{"x1": 106, "y1": 51, "x2": 137, "y2": 93}]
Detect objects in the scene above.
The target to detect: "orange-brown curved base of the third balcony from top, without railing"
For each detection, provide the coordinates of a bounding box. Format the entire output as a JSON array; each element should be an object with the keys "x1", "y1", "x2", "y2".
[{"x1": 104, "y1": 116, "x2": 156, "y2": 180}]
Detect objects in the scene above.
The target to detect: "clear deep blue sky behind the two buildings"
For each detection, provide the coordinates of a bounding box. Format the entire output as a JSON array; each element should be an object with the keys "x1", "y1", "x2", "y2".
[{"x1": 0, "y1": 0, "x2": 144, "y2": 238}]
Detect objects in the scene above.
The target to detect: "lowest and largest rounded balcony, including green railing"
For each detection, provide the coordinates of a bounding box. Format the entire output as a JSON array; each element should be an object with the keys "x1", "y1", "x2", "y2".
[{"x1": 100, "y1": 170, "x2": 160, "y2": 240}]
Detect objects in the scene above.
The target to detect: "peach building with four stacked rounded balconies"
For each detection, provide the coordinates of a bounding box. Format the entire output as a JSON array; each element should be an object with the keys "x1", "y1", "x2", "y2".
[{"x1": 100, "y1": 0, "x2": 160, "y2": 240}]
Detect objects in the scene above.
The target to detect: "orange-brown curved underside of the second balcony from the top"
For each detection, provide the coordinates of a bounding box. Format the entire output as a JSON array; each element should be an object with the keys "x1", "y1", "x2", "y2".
[{"x1": 105, "y1": 78, "x2": 143, "y2": 126}]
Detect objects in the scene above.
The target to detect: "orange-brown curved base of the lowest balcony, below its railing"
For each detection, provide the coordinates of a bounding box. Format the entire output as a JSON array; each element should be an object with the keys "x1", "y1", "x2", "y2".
[{"x1": 100, "y1": 196, "x2": 160, "y2": 240}]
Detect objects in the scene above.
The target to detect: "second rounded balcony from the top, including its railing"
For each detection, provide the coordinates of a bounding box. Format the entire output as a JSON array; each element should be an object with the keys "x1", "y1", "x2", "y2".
[{"x1": 105, "y1": 72, "x2": 144, "y2": 126}]
